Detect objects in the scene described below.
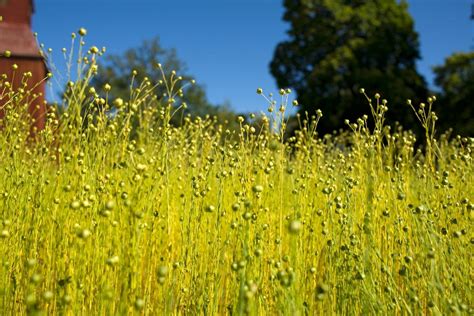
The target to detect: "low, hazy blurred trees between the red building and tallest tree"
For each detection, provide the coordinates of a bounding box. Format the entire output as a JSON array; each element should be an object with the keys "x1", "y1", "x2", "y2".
[{"x1": 92, "y1": 37, "x2": 229, "y2": 123}]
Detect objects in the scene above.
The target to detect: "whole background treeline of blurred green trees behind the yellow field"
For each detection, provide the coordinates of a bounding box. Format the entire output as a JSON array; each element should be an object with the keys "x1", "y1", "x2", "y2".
[{"x1": 71, "y1": 0, "x2": 474, "y2": 136}]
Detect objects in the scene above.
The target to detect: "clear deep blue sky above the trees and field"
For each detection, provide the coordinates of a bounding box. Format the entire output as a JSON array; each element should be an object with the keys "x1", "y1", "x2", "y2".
[{"x1": 33, "y1": 0, "x2": 474, "y2": 111}]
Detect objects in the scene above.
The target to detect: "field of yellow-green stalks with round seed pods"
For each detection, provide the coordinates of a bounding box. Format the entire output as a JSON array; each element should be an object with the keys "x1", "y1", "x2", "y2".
[{"x1": 0, "y1": 30, "x2": 474, "y2": 315}]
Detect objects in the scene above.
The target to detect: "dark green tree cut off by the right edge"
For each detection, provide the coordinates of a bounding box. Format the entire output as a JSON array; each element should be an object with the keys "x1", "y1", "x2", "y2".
[{"x1": 433, "y1": 52, "x2": 474, "y2": 136}]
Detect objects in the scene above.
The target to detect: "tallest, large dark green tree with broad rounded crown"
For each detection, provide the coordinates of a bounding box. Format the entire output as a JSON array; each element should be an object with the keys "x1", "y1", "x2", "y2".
[{"x1": 270, "y1": 0, "x2": 427, "y2": 132}]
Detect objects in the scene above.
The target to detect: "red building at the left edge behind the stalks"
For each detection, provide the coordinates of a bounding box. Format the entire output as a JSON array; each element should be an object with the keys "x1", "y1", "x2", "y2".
[{"x1": 0, "y1": 0, "x2": 47, "y2": 129}]
